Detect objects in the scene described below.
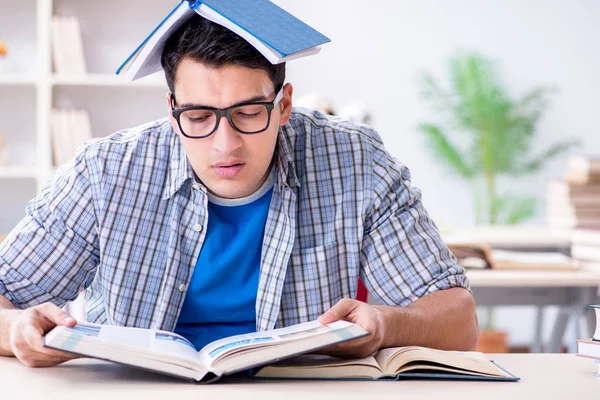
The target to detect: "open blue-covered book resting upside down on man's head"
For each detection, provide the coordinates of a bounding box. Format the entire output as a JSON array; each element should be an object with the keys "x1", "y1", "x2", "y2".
[{"x1": 117, "y1": 0, "x2": 330, "y2": 80}]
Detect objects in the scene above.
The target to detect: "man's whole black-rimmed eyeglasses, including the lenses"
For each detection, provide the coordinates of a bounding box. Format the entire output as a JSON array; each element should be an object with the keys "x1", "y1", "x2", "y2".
[{"x1": 171, "y1": 86, "x2": 283, "y2": 139}]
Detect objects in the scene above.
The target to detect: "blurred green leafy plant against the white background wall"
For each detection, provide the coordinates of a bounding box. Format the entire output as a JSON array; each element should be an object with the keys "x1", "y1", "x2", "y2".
[{"x1": 418, "y1": 52, "x2": 577, "y2": 224}]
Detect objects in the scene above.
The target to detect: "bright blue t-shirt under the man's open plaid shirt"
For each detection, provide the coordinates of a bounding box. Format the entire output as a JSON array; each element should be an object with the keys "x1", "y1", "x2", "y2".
[{"x1": 175, "y1": 174, "x2": 274, "y2": 350}]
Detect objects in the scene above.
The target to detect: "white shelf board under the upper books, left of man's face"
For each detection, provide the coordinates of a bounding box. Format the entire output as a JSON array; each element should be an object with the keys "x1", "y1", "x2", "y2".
[{"x1": 51, "y1": 74, "x2": 167, "y2": 89}]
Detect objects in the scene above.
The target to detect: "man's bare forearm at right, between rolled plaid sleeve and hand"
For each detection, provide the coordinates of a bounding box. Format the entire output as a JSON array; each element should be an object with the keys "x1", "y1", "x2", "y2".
[{"x1": 374, "y1": 288, "x2": 479, "y2": 350}]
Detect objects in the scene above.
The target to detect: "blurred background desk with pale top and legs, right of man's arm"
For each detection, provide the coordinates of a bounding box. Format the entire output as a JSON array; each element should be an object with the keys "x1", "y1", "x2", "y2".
[{"x1": 467, "y1": 268, "x2": 600, "y2": 353}]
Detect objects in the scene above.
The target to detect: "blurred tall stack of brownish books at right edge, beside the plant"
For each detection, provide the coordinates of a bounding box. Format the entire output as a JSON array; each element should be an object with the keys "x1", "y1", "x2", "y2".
[{"x1": 546, "y1": 155, "x2": 600, "y2": 230}]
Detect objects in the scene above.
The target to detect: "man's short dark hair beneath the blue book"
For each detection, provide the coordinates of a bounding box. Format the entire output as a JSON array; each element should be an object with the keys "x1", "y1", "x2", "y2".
[{"x1": 160, "y1": 15, "x2": 285, "y2": 93}]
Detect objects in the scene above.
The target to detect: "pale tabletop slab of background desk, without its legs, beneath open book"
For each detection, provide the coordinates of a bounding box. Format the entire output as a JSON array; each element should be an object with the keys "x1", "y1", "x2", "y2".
[{"x1": 467, "y1": 269, "x2": 600, "y2": 287}]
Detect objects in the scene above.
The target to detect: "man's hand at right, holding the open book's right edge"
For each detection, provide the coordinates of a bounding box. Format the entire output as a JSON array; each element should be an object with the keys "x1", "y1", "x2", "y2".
[{"x1": 319, "y1": 299, "x2": 385, "y2": 358}]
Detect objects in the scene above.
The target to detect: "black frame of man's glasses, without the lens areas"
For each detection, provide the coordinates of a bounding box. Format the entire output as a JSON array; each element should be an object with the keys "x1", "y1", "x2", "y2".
[{"x1": 171, "y1": 85, "x2": 284, "y2": 139}]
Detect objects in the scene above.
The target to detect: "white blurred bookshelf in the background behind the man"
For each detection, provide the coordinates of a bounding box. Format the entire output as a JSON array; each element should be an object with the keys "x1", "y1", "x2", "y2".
[{"x1": 0, "y1": 0, "x2": 176, "y2": 235}]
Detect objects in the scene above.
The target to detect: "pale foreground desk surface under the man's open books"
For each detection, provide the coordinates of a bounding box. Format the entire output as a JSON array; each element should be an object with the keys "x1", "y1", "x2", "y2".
[{"x1": 0, "y1": 354, "x2": 600, "y2": 400}]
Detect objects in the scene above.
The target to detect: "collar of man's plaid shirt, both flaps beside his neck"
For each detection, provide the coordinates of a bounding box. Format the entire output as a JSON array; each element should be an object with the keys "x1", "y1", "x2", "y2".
[{"x1": 163, "y1": 123, "x2": 300, "y2": 200}]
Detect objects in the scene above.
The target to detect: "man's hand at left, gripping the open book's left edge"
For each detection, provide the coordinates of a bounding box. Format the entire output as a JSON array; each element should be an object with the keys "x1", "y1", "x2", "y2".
[{"x1": 2, "y1": 303, "x2": 79, "y2": 367}]
